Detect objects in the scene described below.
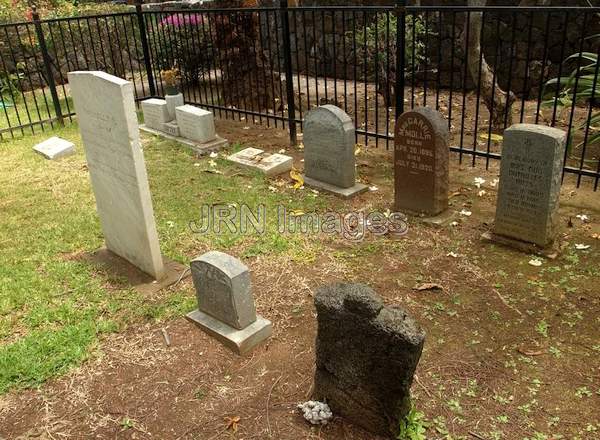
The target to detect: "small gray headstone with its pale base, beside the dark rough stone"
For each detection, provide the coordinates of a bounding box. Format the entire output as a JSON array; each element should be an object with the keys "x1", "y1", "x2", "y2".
[{"x1": 187, "y1": 251, "x2": 272, "y2": 354}]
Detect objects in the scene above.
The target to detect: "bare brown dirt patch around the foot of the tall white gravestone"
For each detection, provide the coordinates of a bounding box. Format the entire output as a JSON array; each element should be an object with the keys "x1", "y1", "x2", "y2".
[{"x1": 83, "y1": 248, "x2": 189, "y2": 296}]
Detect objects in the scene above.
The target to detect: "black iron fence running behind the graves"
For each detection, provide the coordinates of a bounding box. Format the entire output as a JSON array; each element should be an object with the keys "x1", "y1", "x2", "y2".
[{"x1": 0, "y1": 0, "x2": 600, "y2": 189}]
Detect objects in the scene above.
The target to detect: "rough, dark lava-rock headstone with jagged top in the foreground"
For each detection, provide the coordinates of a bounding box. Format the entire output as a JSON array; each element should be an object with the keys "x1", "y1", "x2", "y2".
[{"x1": 314, "y1": 283, "x2": 425, "y2": 438}]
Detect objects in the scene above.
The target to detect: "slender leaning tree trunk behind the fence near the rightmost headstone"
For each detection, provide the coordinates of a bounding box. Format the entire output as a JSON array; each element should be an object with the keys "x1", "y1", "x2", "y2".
[{"x1": 467, "y1": 0, "x2": 516, "y2": 131}]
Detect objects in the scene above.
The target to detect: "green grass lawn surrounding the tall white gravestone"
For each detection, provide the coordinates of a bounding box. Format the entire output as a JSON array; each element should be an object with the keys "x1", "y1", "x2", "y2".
[{"x1": 0, "y1": 124, "x2": 328, "y2": 393}]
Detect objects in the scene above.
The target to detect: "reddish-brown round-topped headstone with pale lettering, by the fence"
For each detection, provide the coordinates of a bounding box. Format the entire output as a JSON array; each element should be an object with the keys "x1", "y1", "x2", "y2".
[{"x1": 394, "y1": 107, "x2": 449, "y2": 216}]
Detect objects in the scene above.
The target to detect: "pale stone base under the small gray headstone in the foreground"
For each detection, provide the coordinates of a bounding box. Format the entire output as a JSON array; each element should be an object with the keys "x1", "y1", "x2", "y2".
[{"x1": 185, "y1": 310, "x2": 273, "y2": 354}]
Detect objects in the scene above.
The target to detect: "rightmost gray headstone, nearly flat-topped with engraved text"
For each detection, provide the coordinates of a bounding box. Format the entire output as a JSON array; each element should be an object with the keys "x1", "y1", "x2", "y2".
[{"x1": 494, "y1": 124, "x2": 567, "y2": 247}]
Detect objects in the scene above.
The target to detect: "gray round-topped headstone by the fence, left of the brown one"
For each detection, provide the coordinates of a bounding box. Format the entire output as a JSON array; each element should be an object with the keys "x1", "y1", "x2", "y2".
[{"x1": 303, "y1": 105, "x2": 367, "y2": 197}]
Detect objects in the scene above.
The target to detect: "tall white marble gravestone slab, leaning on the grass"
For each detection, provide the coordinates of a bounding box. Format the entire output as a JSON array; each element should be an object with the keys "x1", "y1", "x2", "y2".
[{"x1": 69, "y1": 71, "x2": 165, "y2": 280}]
